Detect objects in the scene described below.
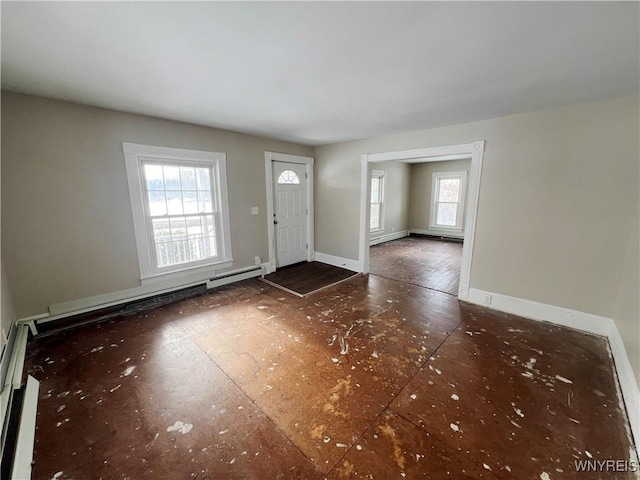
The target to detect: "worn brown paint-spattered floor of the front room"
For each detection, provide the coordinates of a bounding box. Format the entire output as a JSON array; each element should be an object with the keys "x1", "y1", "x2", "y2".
[{"x1": 27, "y1": 275, "x2": 635, "y2": 480}]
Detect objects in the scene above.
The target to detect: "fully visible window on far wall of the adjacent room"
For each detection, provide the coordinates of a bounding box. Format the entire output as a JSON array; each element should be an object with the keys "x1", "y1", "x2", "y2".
[{"x1": 429, "y1": 172, "x2": 467, "y2": 231}]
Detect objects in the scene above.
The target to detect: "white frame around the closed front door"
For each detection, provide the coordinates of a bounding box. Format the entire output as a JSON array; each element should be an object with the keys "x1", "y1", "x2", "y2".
[{"x1": 264, "y1": 152, "x2": 316, "y2": 273}]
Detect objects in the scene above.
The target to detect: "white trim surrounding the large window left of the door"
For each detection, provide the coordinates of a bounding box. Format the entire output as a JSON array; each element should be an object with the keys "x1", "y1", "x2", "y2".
[{"x1": 122, "y1": 142, "x2": 233, "y2": 285}]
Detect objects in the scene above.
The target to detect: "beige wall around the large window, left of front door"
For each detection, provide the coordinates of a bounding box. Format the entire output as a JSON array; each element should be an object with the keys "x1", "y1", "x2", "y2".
[{"x1": 2, "y1": 92, "x2": 313, "y2": 317}]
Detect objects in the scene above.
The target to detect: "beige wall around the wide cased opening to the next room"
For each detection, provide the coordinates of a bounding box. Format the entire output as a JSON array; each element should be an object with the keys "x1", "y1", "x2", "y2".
[{"x1": 316, "y1": 95, "x2": 640, "y2": 386}]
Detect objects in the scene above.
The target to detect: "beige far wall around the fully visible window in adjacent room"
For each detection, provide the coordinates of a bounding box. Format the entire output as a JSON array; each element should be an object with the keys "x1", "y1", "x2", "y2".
[{"x1": 409, "y1": 159, "x2": 471, "y2": 234}]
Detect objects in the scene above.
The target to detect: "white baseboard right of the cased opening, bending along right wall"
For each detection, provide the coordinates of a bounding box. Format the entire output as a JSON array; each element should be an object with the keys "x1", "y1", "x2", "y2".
[{"x1": 468, "y1": 288, "x2": 640, "y2": 446}]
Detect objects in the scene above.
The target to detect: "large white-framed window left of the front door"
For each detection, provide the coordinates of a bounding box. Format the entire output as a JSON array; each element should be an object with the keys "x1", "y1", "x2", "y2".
[{"x1": 123, "y1": 143, "x2": 231, "y2": 280}]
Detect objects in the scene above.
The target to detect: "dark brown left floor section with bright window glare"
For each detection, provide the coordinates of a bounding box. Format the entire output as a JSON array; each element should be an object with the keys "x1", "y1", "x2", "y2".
[{"x1": 30, "y1": 310, "x2": 321, "y2": 479}]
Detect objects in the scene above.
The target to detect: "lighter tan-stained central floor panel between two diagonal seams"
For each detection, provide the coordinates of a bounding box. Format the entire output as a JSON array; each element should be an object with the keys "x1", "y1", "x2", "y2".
[{"x1": 180, "y1": 279, "x2": 459, "y2": 473}]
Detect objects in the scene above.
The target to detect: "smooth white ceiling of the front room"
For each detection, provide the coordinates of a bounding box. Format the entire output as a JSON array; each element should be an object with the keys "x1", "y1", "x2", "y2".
[{"x1": 1, "y1": 1, "x2": 640, "y2": 145}]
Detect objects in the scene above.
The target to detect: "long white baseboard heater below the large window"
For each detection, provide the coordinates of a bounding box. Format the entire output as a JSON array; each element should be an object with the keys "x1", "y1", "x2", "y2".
[{"x1": 23, "y1": 264, "x2": 265, "y2": 324}]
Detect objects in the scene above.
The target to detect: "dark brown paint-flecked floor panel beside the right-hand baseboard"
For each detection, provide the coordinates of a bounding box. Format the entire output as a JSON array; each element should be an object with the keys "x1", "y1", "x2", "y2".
[{"x1": 391, "y1": 307, "x2": 635, "y2": 479}]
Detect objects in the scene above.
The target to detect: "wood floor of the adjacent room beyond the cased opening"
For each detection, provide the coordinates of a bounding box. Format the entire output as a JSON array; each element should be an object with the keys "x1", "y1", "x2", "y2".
[{"x1": 369, "y1": 236, "x2": 462, "y2": 296}]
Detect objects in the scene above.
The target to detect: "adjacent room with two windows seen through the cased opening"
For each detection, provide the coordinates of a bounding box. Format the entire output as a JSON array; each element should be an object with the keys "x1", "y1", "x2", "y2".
[{"x1": 369, "y1": 157, "x2": 471, "y2": 296}]
